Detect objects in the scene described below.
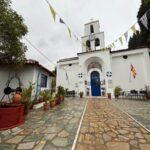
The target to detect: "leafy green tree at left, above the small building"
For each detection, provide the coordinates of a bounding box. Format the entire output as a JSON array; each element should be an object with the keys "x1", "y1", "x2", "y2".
[{"x1": 0, "y1": 0, "x2": 27, "y2": 63}]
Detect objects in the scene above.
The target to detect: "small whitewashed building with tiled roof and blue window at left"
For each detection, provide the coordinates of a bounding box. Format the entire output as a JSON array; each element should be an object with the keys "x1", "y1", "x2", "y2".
[{"x1": 0, "y1": 60, "x2": 54, "y2": 100}]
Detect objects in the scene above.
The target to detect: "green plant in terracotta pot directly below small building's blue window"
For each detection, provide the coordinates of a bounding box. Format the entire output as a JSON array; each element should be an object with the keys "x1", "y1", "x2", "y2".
[{"x1": 40, "y1": 90, "x2": 51, "y2": 110}]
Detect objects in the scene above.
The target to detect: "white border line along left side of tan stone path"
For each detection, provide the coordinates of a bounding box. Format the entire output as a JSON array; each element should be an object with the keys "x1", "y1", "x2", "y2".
[{"x1": 71, "y1": 100, "x2": 88, "y2": 150}]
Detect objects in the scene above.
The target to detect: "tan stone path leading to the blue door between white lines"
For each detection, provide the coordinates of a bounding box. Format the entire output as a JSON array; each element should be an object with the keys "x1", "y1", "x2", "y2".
[{"x1": 76, "y1": 100, "x2": 150, "y2": 150}]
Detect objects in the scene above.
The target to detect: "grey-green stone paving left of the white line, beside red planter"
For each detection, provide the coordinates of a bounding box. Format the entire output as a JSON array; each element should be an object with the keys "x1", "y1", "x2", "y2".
[{"x1": 0, "y1": 98, "x2": 86, "y2": 150}]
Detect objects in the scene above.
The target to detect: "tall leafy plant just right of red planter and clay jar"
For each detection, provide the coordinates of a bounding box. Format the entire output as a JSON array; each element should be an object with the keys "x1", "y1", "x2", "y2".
[{"x1": 21, "y1": 83, "x2": 34, "y2": 115}]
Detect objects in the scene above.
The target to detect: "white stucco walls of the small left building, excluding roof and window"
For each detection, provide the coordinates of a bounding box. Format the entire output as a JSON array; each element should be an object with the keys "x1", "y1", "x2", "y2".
[{"x1": 0, "y1": 65, "x2": 51, "y2": 99}]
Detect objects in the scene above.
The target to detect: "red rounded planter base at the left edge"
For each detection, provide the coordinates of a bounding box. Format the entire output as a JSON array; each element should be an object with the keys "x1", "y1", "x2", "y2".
[{"x1": 0, "y1": 104, "x2": 24, "y2": 131}]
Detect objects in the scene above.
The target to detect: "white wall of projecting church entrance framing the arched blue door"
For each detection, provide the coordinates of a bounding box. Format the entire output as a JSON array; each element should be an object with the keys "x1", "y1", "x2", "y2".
[{"x1": 78, "y1": 50, "x2": 113, "y2": 95}]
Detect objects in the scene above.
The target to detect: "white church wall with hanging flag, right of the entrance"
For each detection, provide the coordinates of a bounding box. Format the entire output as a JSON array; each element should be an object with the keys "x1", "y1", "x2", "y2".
[{"x1": 111, "y1": 49, "x2": 150, "y2": 91}]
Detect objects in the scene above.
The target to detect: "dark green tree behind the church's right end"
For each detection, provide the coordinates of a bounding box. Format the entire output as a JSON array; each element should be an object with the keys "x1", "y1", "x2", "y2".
[{"x1": 128, "y1": 0, "x2": 150, "y2": 49}]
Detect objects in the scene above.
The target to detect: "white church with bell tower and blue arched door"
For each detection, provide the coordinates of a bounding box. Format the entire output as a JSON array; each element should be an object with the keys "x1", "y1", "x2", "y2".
[{"x1": 57, "y1": 21, "x2": 150, "y2": 97}]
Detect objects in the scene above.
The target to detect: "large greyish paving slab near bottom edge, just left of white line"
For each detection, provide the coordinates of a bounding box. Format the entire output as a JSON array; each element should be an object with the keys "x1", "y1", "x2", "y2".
[{"x1": 52, "y1": 137, "x2": 68, "y2": 147}]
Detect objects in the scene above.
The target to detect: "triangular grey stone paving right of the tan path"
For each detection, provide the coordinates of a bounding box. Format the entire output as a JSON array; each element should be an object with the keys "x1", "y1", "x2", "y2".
[{"x1": 113, "y1": 99, "x2": 150, "y2": 130}]
